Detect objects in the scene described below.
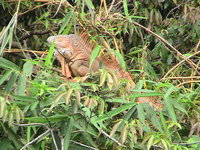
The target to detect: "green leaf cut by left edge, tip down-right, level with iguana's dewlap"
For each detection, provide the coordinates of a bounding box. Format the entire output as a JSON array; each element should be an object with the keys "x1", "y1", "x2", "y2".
[{"x1": 0, "y1": 57, "x2": 20, "y2": 71}]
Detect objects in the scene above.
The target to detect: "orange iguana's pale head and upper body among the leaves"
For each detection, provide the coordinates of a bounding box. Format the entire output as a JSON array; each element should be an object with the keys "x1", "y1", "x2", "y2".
[{"x1": 47, "y1": 34, "x2": 134, "y2": 84}]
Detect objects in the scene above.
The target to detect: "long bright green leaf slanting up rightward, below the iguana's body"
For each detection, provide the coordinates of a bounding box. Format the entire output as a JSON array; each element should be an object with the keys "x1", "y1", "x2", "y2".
[{"x1": 94, "y1": 102, "x2": 135, "y2": 123}]
